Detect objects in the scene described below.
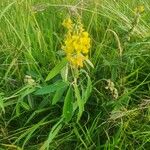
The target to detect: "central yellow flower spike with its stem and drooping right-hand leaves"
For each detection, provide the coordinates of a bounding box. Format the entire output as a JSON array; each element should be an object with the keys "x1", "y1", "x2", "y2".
[{"x1": 62, "y1": 16, "x2": 92, "y2": 122}]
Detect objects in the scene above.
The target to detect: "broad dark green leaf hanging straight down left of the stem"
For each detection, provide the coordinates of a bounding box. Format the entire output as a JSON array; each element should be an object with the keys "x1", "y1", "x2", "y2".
[{"x1": 63, "y1": 86, "x2": 73, "y2": 122}]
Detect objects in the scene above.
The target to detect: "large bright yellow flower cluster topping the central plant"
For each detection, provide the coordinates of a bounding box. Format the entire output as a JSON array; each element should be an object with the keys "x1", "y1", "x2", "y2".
[{"x1": 62, "y1": 18, "x2": 90, "y2": 68}]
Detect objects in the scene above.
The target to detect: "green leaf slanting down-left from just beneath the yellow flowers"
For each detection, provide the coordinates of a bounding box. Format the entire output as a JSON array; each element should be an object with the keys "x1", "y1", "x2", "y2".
[{"x1": 46, "y1": 58, "x2": 67, "y2": 81}]
